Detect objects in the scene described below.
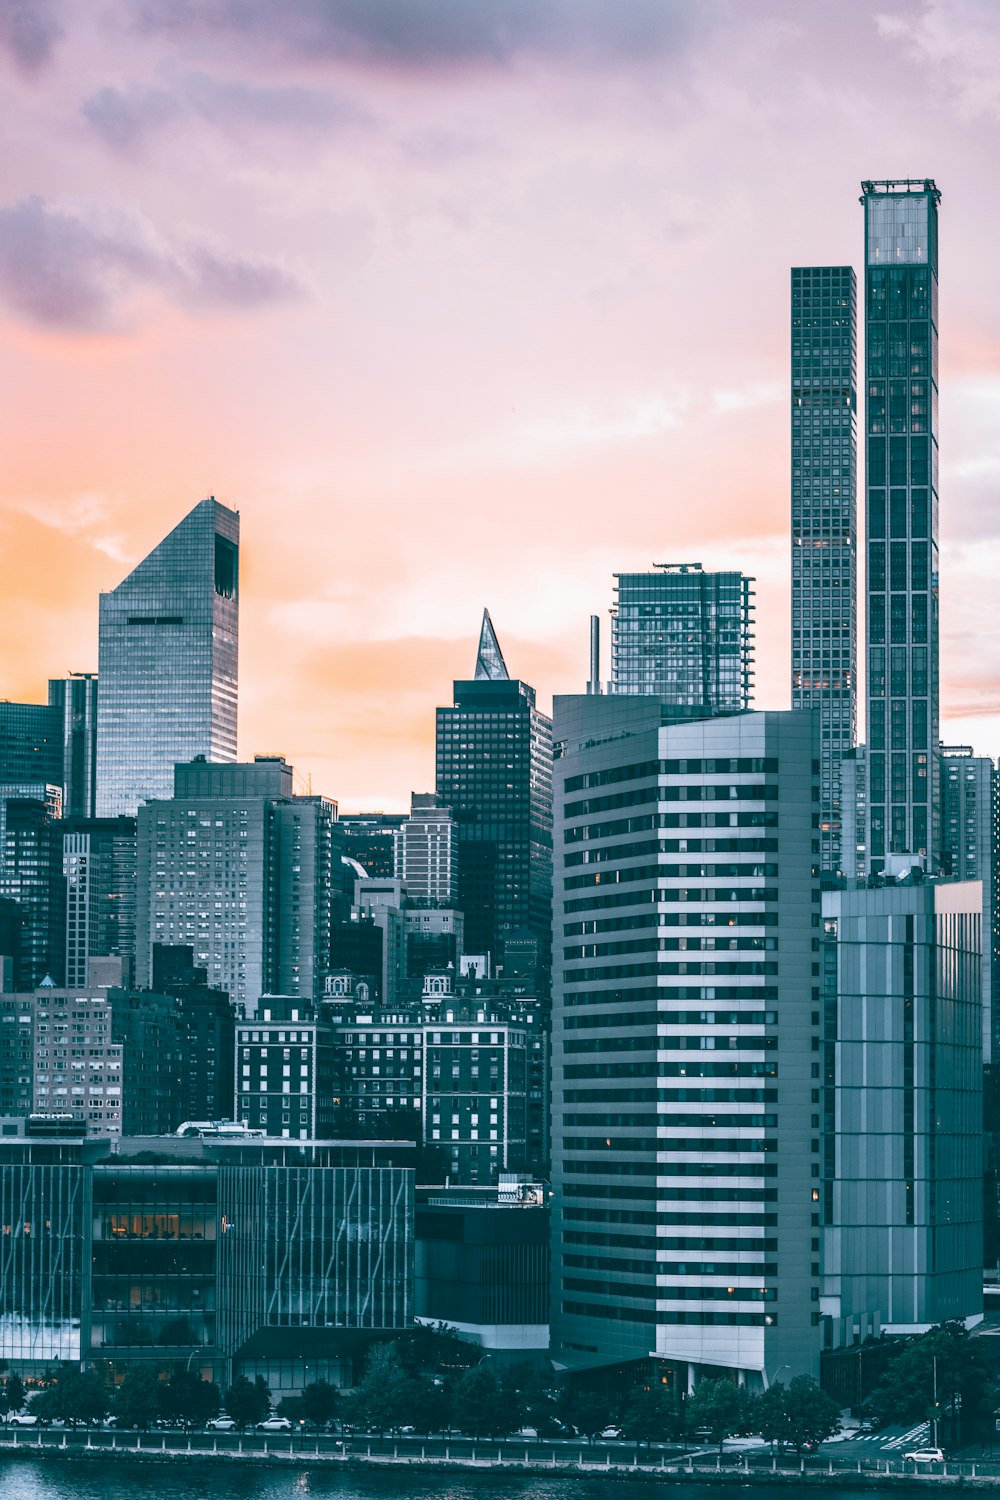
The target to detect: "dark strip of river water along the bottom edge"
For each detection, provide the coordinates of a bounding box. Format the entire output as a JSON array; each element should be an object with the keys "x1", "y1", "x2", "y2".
[{"x1": 0, "y1": 1458, "x2": 893, "y2": 1500}]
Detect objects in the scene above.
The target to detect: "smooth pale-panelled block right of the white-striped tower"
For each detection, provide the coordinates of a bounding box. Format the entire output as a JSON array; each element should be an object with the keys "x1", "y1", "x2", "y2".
[{"x1": 814, "y1": 876, "x2": 982, "y2": 1349}]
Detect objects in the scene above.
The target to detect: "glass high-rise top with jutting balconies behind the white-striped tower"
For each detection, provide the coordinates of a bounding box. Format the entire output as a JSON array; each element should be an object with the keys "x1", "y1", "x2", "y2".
[{"x1": 609, "y1": 563, "x2": 754, "y2": 719}]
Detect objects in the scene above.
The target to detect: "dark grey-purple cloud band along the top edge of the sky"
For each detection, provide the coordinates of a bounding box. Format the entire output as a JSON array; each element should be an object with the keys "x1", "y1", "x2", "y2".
[{"x1": 130, "y1": 0, "x2": 694, "y2": 69}]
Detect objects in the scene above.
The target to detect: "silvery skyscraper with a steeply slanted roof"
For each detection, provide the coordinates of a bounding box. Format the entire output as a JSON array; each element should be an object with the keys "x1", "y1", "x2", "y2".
[{"x1": 97, "y1": 497, "x2": 240, "y2": 818}]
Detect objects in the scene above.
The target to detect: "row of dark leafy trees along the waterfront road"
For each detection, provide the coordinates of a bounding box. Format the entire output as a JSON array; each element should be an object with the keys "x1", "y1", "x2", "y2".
[{"x1": 0, "y1": 1323, "x2": 1000, "y2": 1452}]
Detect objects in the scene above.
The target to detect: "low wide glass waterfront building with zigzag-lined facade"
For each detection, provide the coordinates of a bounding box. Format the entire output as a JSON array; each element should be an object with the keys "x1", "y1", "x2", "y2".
[{"x1": 0, "y1": 1136, "x2": 414, "y2": 1380}]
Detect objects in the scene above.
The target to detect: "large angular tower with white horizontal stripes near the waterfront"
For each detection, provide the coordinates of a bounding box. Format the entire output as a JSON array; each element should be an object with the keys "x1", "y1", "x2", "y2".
[{"x1": 552, "y1": 695, "x2": 820, "y2": 1392}]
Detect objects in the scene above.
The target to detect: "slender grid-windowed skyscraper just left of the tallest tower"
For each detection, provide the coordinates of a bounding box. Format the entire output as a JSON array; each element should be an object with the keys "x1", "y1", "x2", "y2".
[{"x1": 792, "y1": 266, "x2": 858, "y2": 875}]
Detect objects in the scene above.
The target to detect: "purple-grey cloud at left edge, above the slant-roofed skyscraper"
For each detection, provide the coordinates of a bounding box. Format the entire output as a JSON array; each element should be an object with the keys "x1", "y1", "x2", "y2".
[{"x1": 0, "y1": 197, "x2": 303, "y2": 330}]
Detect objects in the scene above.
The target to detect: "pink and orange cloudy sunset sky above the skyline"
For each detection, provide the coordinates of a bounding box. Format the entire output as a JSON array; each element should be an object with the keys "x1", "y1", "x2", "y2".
[{"x1": 0, "y1": 0, "x2": 1000, "y2": 812}]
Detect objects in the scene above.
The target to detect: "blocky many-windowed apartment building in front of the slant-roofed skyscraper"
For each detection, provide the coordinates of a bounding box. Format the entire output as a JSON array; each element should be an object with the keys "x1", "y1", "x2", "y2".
[{"x1": 136, "y1": 756, "x2": 340, "y2": 1016}]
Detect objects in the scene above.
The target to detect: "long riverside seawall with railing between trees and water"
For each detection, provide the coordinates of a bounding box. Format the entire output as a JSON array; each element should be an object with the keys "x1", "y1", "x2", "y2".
[{"x1": 0, "y1": 1442, "x2": 983, "y2": 1491}]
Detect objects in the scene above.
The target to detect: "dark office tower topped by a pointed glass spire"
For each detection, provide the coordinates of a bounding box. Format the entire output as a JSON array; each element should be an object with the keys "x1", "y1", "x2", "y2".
[{"x1": 436, "y1": 617, "x2": 552, "y2": 966}]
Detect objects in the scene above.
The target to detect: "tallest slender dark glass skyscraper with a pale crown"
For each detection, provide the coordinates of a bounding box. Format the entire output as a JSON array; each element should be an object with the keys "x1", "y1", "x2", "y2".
[{"x1": 861, "y1": 179, "x2": 942, "y2": 872}]
